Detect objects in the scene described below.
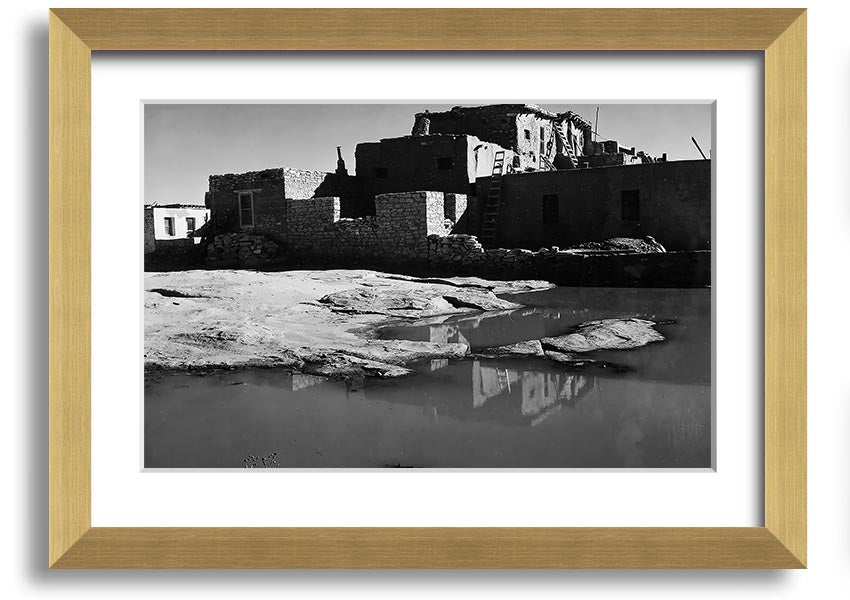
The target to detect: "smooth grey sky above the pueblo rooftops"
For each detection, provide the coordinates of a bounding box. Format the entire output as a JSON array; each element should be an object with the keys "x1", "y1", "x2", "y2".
[{"x1": 142, "y1": 100, "x2": 712, "y2": 204}]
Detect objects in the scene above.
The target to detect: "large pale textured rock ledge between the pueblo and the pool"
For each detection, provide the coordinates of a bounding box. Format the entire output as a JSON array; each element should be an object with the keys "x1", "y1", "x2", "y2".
[{"x1": 144, "y1": 270, "x2": 553, "y2": 377}]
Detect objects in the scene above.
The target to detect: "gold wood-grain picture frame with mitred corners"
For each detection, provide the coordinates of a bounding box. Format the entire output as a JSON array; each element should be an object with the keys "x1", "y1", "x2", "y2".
[{"x1": 48, "y1": 9, "x2": 806, "y2": 569}]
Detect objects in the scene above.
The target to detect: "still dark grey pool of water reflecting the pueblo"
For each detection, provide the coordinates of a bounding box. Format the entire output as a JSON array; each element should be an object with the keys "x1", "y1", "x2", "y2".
[{"x1": 145, "y1": 288, "x2": 711, "y2": 468}]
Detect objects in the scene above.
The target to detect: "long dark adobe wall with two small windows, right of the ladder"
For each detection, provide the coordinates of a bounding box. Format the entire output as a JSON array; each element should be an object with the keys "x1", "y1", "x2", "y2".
[{"x1": 470, "y1": 160, "x2": 711, "y2": 250}]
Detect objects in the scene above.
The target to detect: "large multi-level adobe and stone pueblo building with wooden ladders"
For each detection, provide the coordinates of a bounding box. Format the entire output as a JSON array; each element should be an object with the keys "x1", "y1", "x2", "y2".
[{"x1": 174, "y1": 104, "x2": 711, "y2": 287}]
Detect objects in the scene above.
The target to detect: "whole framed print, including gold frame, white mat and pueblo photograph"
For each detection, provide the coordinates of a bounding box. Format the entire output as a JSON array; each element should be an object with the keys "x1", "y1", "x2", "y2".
[{"x1": 49, "y1": 9, "x2": 806, "y2": 568}]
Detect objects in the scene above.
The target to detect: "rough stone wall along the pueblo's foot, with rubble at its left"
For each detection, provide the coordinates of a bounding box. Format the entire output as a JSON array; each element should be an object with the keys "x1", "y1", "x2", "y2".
[{"x1": 200, "y1": 191, "x2": 711, "y2": 287}]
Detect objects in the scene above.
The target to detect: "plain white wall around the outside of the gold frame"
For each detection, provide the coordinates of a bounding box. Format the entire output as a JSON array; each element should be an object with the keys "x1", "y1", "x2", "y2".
[{"x1": 6, "y1": 0, "x2": 850, "y2": 600}]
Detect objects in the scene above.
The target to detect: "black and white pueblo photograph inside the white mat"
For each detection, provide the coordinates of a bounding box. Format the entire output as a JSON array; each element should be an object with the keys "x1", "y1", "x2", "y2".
[{"x1": 140, "y1": 98, "x2": 715, "y2": 469}]
